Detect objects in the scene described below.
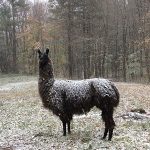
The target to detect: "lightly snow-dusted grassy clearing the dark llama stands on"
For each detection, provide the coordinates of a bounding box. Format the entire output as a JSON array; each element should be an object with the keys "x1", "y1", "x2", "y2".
[{"x1": 0, "y1": 76, "x2": 150, "y2": 150}]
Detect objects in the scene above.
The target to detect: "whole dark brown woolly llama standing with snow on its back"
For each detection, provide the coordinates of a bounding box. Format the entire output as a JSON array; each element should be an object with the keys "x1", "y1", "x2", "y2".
[{"x1": 38, "y1": 49, "x2": 119, "y2": 140}]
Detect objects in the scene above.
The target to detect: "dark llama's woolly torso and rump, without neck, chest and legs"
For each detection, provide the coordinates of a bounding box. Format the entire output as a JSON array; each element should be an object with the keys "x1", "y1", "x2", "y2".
[{"x1": 53, "y1": 78, "x2": 119, "y2": 114}]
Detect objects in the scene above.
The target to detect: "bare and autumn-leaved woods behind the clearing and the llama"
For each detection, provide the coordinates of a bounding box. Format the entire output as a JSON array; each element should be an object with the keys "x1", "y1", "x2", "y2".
[{"x1": 0, "y1": 0, "x2": 150, "y2": 82}]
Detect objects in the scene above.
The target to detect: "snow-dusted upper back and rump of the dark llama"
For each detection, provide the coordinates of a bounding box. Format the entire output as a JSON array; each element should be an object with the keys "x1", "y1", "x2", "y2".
[{"x1": 53, "y1": 78, "x2": 119, "y2": 99}]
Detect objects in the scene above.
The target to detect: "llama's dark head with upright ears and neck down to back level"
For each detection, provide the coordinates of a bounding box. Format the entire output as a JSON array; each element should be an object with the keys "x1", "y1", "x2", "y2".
[{"x1": 38, "y1": 48, "x2": 53, "y2": 79}]
